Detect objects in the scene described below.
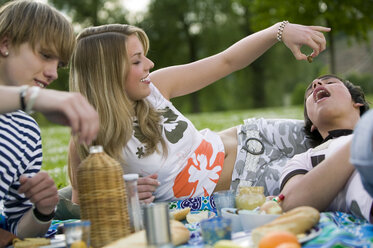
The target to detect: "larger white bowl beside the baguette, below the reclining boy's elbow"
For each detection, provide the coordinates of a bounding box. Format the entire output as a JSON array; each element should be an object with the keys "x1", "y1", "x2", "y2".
[{"x1": 238, "y1": 210, "x2": 280, "y2": 231}]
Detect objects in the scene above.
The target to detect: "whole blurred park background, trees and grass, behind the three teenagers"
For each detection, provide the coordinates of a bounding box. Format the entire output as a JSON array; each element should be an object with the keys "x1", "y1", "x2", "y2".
[{"x1": 4, "y1": 0, "x2": 373, "y2": 188}]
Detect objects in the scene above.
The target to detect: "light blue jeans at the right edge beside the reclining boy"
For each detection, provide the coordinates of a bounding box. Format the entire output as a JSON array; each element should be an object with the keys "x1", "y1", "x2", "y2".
[{"x1": 350, "y1": 109, "x2": 373, "y2": 196}]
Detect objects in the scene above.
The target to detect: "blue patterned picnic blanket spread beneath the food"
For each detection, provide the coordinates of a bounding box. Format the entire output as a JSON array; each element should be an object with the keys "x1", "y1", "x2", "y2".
[{"x1": 0, "y1": 196, "x2": 373, "y2": 248}]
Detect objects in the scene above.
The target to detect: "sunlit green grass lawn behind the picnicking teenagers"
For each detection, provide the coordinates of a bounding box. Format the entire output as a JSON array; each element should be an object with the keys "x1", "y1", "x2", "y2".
[{"x1": 41, "y1": 95, "x2": 373, "y2": 188}]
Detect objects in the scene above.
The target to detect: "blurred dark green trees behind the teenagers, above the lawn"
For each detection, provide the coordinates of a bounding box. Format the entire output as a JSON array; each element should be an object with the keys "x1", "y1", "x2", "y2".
[{"x1": 0, "y1": 0, "x2": 373, "y2": 114}]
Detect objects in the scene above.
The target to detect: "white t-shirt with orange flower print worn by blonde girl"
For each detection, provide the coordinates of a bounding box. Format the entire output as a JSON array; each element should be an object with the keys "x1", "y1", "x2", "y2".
[{"x1": 122, "y1": 84, "x2": 224, "y2": 201}]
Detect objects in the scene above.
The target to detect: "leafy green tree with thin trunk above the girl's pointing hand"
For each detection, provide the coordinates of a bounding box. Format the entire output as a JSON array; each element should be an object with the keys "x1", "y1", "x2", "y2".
[{"x1": 246, "y1": 0, "x2": 373, "y2": 73}]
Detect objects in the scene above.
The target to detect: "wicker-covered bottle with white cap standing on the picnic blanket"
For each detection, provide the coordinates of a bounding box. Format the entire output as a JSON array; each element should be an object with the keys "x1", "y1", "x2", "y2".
[{"x1": 77, "y1": 146, "x2": 131, "y2": 247}]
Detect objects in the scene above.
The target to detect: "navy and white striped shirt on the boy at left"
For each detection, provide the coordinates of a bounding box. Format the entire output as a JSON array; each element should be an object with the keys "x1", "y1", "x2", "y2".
[{"x1": 0, "y1": 111, "x2": 43, "y2": 234}]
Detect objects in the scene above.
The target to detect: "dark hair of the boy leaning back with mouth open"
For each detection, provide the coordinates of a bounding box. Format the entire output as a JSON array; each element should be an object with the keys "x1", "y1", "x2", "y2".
[{"x1": 304, "y1": 75, "x2": 369, "y2": 146}]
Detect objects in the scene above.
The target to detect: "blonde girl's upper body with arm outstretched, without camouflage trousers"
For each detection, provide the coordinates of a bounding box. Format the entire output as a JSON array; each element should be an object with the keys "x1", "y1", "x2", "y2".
[{"x1": 69, "y1": 22, "x2": 329, "y2": 203}]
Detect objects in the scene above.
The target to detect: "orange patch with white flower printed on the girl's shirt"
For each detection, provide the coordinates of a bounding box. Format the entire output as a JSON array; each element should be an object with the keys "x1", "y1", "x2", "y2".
[{"x1": 172, "y1": 140, "x2": 224, "y2": 198}]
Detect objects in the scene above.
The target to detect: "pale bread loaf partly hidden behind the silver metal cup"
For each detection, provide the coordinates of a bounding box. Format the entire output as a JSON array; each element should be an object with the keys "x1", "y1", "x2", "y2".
[{"x1": 104, "y1": 220, "x2": 190, "y2": 248}]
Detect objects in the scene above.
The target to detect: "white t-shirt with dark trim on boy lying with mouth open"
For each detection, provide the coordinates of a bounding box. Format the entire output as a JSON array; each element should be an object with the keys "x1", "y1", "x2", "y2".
[{"x1": 280, "y1": 135, "x2": 373, "y2": 221}]
